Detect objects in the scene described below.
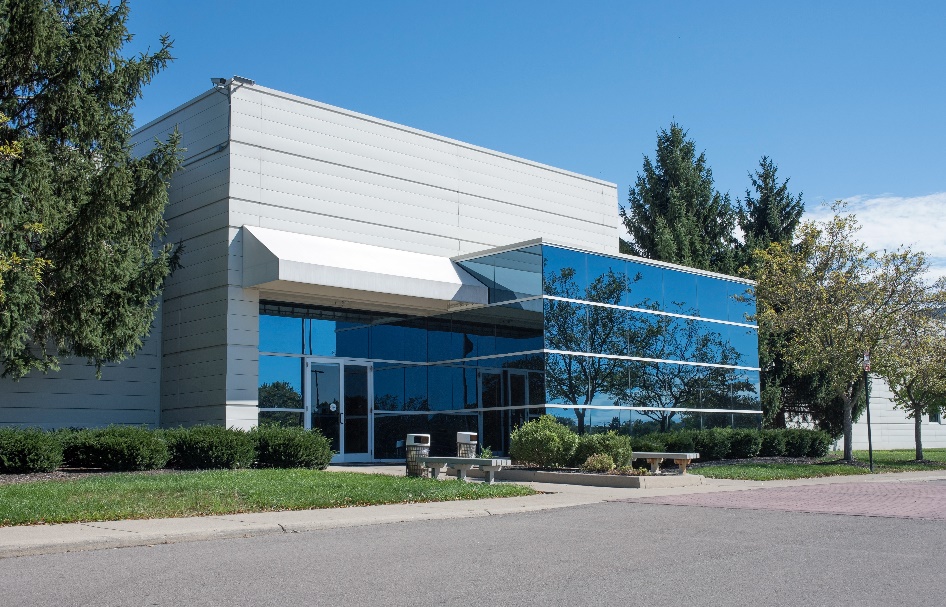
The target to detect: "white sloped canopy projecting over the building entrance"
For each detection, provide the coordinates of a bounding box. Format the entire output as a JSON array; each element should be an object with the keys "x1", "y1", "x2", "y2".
[{"x1": 243, "y1": 226, "x2": 489, "y2": 310}]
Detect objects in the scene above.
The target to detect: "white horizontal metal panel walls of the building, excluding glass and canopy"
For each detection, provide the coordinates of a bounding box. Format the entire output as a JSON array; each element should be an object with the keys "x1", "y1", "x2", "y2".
[{"x1": 0, "y1": 83, "x2": 619, "y2": 428}]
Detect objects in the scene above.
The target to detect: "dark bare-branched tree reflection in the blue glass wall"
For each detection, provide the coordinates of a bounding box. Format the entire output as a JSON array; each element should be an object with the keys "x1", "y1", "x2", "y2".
[{"x1": 544, "y1": 254, "x2": 756, "y2": 433}]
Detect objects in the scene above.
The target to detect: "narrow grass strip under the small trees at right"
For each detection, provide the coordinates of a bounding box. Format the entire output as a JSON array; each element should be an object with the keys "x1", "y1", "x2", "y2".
[{"x1": 693, "y1": 449, "x2": 946, "y2": 481}]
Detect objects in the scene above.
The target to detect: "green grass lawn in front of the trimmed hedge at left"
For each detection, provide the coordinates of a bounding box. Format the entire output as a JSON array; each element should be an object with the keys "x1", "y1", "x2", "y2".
[{"x1": 0, "y1": 470, "x2": 535, "y2": 526}]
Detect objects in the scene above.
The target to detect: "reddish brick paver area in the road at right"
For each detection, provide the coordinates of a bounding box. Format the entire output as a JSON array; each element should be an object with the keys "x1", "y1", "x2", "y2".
[{"x1": 621, "y1": 481, "x2": 946, "y2": 521}]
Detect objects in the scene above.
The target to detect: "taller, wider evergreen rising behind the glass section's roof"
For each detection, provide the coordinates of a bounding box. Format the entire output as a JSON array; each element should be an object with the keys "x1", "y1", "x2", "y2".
[{"x1": 621, "y1": 123, "x2": 736, "y2": 274}]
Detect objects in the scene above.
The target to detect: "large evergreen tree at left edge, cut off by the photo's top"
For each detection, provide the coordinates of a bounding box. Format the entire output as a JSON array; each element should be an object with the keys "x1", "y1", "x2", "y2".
[{"x1": 0, "y1": 0, "x2": 179, "y2": 378}]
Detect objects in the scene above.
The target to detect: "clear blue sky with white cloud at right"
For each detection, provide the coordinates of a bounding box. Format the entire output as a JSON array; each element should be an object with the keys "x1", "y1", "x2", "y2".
[{"x1": 129, "y1": 0, "x2": 946, "y2": 274}]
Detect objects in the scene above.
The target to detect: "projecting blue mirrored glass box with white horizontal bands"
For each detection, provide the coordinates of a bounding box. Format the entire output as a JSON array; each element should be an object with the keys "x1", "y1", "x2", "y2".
[{"x1": 460, "y1": 244, "x2": 761, "y2": 433}]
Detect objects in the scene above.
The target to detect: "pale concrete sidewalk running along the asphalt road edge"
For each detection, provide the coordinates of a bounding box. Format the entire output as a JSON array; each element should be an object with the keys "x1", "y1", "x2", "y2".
[{"x1": 0, "y1": 466, "x2": 946, "y2": 558}]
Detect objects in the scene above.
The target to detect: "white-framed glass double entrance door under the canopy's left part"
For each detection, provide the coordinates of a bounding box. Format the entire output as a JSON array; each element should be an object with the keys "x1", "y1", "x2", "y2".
[{"x1": 306, "y1": 358, "x2": 373, "y2": 462}]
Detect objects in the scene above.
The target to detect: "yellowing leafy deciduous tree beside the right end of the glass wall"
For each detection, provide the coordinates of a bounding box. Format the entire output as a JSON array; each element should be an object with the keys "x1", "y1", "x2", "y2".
[{"x1": 756, "y1": 203, "x2": 926, "y2": 460}]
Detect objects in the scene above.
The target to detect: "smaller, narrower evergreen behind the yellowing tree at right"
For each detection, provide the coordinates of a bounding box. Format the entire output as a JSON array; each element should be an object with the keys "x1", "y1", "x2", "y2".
[{"x1": 738, "y1": 156, "x2": 805, "y2": 263}]
